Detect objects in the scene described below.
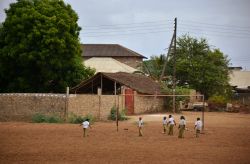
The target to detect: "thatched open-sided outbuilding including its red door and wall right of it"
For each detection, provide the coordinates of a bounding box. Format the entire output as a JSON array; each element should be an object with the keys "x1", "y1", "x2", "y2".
[{"x1": 70, "y1": 72, "x2": 164, "y2": 114}]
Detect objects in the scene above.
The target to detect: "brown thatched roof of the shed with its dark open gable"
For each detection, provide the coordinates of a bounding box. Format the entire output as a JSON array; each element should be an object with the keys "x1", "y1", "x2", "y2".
[{"x1": 71, "y1": 72, "x2": 161, "y2": 95}]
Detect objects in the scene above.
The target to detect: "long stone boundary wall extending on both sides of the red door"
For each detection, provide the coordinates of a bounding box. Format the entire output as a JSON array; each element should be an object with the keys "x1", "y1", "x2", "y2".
[{"x1": 0, "y1": 93, "x2": 164, "y2": 121}]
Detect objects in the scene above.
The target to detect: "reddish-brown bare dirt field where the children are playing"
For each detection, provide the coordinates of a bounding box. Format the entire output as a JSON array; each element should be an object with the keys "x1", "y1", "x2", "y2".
[{"x1": 0, "y1": 112, "x2": 250, "y2": 164}]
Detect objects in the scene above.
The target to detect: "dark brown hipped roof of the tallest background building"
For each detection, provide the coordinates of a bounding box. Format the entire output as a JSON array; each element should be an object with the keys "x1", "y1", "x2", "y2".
[{"x1": 81, "y1": 44, "x2": 146, "y2": 58}]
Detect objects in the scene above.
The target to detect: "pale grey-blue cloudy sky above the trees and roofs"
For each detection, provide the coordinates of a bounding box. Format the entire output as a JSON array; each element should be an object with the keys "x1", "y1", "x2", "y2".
[{"x1": 0, "y1": 0, "x2": 250, "y2": 71}]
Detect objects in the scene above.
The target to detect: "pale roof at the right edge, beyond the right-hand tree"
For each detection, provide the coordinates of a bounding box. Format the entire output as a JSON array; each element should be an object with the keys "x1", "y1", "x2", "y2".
[{"x1": 229, "y1": 70, "x2": 250, "y2": 89}]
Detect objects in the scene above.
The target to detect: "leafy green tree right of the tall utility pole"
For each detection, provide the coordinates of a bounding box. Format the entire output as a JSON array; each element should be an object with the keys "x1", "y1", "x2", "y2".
[{"x1": 167, "y1": 35, "x2": 229, "y2": 98}]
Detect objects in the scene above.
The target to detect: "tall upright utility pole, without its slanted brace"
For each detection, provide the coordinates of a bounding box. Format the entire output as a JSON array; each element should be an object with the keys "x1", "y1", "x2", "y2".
[{"x1": 173, "y1": 18, "x2": 177, "y2": 113}]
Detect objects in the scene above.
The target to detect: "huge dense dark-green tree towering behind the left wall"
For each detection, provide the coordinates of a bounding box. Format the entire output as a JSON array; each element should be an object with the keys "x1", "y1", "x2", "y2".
[{"x1": 0, "y1": 0, "x2": 94, "y2": 92}]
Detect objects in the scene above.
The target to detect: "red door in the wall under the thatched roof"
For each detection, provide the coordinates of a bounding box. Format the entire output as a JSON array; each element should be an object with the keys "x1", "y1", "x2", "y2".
[{"x1": 125, "y1": 88, "x2": 134, "y2": 114}]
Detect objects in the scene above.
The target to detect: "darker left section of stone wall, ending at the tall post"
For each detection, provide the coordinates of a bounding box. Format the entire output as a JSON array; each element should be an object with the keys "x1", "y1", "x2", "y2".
[{"x1": 0, "y1": 93, "x2": 66, "y2": 121}]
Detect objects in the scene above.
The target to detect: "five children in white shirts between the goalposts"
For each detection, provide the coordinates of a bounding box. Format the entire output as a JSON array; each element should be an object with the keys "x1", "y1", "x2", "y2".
[{"x1": 138, "y1": 115, "x2": 202, "y2": 138}]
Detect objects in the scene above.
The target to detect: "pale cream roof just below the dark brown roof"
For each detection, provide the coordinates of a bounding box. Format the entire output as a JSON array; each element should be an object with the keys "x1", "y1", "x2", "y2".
[{"x1": 84, "y1": 57, "x2": 139, "y2": 73}]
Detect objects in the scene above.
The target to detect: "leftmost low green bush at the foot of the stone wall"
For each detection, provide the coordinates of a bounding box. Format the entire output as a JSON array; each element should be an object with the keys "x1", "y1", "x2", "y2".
[{"x1": 32, "y1": 113, "x2": 63, "y2": 123}]
